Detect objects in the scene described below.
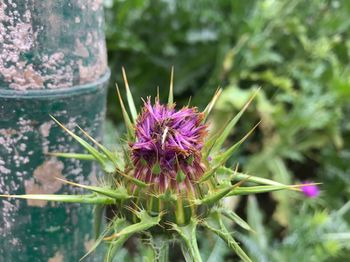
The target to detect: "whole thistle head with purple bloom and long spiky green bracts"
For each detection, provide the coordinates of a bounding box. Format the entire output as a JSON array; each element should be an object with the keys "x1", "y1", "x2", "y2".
[{"x1": 3, "y1": 69, "x2": 312, "y2": 262}]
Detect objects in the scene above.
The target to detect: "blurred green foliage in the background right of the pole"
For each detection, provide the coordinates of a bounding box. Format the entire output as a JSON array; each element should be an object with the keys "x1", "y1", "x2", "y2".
[{"x1": 105, "y1": 0, "x2": 350, "y2": 261}]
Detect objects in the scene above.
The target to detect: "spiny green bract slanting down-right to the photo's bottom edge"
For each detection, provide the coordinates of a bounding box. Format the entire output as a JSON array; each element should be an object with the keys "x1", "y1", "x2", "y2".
[{"x1": 202, "y1": 211, "x2": 252, "y2": 262}]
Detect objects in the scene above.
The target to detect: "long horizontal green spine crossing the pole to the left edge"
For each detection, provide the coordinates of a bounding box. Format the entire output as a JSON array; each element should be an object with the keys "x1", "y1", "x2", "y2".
[{"x1": 0, "y1": 194, "x2": 115, "y2": 205}]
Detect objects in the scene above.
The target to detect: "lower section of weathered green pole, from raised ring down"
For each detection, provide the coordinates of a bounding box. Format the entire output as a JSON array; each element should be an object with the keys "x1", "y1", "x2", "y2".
[{"x1": 0, "y1": 74, "x2": 108, "y2": 261}]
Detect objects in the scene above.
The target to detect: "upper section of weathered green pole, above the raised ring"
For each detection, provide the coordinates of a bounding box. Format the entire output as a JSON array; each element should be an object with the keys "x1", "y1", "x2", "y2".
[{"x1": 0, "y1": 0, "x2": 107, "y2": 91}]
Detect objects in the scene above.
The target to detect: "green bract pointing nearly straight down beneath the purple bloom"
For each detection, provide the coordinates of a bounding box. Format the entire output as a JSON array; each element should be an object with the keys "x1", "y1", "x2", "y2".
[{"x1": 171, "y1": 218, "x2": 202, "y2": 262}]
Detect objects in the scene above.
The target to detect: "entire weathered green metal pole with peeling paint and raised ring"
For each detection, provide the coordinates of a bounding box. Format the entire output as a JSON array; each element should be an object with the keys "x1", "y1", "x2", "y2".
[{"x1": 0, "y1": 0, "x2": 109, "y2": 262}]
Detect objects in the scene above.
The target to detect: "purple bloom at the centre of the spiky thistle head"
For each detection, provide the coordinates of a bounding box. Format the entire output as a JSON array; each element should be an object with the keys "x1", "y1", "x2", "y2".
[{"x1": 130, "y1": 98, "x2": 207, "y2": 191}]
